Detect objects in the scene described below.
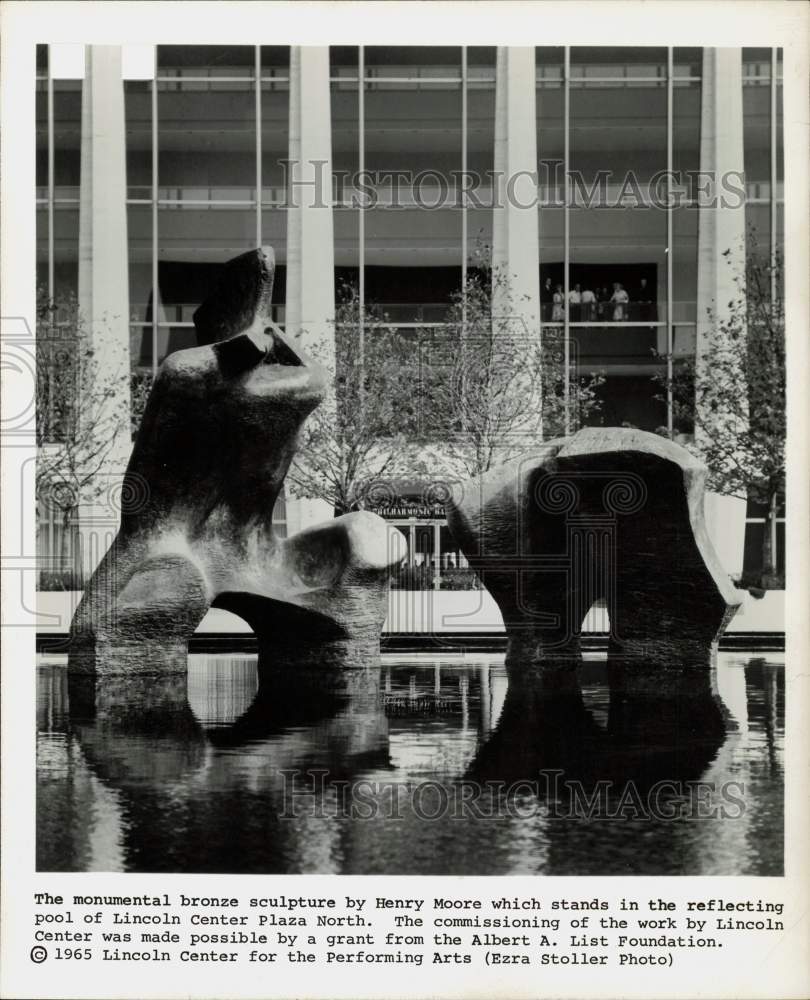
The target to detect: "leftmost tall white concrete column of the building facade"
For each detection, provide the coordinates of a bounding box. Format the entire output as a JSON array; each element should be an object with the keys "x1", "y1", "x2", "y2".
[{"x1": 79, "y1": 45, "x2": 131, "y2": 573}]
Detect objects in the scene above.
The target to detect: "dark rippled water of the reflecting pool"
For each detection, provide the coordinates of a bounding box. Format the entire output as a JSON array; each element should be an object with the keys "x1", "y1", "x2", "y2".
[{"x1": 37, "y1": 654, "x2": 784, "y2": 875}]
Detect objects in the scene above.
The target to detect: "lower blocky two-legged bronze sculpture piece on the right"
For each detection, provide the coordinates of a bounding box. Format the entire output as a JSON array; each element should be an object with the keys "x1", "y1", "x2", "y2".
[{"x1": 448, "y1": 428, "x2": 740, "y2": 676}]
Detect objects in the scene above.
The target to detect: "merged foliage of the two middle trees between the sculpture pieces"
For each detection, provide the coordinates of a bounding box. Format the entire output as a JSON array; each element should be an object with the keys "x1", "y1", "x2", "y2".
[{"x1": 287, "y1": 254, "x2": 602, "y2": 513}]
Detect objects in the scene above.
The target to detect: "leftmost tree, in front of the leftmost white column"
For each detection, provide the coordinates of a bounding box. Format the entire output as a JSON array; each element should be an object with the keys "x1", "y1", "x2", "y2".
[{"x1": 36, "y1": 290, "x2": 128, "y2": 585}]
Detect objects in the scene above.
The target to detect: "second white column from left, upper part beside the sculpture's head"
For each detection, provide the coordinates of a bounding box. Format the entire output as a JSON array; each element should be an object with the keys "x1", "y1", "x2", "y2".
[{"x1": 286, "y1": 46, "x2": 335, "y2": 362}]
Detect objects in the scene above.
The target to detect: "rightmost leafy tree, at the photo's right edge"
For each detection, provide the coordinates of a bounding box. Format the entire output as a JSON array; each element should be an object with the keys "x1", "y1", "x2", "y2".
[{"x1": 659, "y1": 238, "x2": 786, "y2": 587}]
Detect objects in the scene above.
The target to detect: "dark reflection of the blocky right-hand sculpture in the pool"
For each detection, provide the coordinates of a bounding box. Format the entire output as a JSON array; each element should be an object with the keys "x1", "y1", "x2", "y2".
[{"x1": 468, "y1": 647, "x2": 729, "y2": 796}]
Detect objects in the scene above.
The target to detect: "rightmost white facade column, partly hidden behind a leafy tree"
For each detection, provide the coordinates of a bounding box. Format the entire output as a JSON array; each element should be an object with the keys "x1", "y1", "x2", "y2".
[{"x1": 695, "y1": 48, "x2": 746, "y2": 576}]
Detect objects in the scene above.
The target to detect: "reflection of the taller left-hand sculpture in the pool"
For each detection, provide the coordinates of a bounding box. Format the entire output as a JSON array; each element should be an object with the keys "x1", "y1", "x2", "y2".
[{"x1": 57, "y1": 658, "x2": 387, "y2": 873}]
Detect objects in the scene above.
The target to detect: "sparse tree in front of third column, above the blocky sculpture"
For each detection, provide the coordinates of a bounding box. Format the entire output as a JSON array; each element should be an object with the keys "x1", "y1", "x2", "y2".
[{"x1": 416, "y1": 256, "x2": 602, "y2": 476}]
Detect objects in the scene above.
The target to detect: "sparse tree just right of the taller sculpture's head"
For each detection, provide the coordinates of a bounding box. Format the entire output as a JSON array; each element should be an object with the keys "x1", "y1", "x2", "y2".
[{"x1": 286, "y1": 285, "x2": 430, "y2": 514}]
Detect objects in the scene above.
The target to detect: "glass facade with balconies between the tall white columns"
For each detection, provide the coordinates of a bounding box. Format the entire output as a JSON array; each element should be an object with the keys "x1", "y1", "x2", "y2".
[{"x1": 36, "y1": 46, "x2": 784, "y2": 584}]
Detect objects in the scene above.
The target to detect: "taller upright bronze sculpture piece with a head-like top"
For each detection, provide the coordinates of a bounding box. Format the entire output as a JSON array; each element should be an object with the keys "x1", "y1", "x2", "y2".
[{"x1": 69, "y1": 249, "x2": 405, "y2": 674}]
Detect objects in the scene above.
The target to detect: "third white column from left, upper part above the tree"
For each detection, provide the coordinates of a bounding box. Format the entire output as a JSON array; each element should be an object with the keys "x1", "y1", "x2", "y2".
[{"x1": 492, "y1": 46, "x2": 540, "y2": 336}]
